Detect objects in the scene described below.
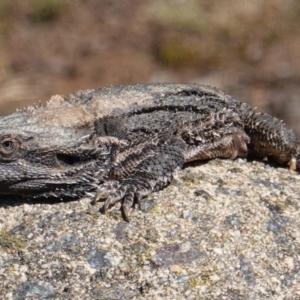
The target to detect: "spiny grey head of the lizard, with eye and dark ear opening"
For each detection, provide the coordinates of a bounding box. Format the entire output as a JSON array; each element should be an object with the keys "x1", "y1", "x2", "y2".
[{"x1": 0, "y1": 129, "x2": 125, "y2": 199}]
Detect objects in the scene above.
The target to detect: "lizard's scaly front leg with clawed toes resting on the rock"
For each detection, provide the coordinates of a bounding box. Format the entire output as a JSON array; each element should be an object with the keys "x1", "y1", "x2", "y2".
[{"x1": 95, "y1": 141, "x2": 185, "y2": 221}]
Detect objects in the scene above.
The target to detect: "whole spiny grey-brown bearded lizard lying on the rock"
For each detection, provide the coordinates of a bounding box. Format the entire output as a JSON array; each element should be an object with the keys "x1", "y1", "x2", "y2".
[{"x1": 0, "y1": 83, "x2": 300, "y2": 219}]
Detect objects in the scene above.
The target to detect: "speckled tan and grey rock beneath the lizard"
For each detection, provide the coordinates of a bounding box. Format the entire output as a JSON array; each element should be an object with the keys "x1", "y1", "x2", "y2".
[{"x1": 0, "y1": 159, "x2": 300, "y2": 300}]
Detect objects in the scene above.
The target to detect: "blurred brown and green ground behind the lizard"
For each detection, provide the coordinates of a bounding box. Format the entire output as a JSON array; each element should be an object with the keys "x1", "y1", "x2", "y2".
[{"x1": 0, "y1": 0, "x2": 300, "y2": 137}]
